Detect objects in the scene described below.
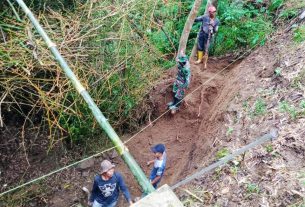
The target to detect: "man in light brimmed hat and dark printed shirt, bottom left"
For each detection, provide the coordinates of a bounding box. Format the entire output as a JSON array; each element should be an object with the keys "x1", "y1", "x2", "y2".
[{"x1": 89, "y1": 160, "x2": 132, "y2": 207}]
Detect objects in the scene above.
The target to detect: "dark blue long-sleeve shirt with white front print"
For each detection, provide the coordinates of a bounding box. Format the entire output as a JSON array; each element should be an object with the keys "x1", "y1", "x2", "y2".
[{"x1": 89, "y1": 172, "x2": 131, "y2": 206}]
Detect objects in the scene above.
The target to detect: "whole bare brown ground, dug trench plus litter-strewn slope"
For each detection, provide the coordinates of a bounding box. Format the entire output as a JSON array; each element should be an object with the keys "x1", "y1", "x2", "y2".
[{"x1": 0, "y1": 25, "x2": 305, "y2": 207}]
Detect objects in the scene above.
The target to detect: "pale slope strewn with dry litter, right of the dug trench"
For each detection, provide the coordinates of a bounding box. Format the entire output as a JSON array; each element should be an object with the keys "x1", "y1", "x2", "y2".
[{"x1": 180, "y1": 31, "x2": 305, "y2": 206}]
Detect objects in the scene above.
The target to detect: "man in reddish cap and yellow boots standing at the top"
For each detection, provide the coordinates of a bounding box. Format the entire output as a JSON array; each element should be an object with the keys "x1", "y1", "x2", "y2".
[{"x1": 195, "y1": 6, "x2": 219, "y2": 68}]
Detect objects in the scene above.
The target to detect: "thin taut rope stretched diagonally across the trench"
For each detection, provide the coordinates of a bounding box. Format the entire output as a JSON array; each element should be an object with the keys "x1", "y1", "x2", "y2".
[{"x1": 0, "y1": 36, "x2": 259, "y2": 197}]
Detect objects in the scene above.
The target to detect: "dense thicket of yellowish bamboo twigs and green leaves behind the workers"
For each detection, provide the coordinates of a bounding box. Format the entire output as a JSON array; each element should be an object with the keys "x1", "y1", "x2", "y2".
[{"x1": 0, "y1": 0, "x2": 302, "y2": 145}]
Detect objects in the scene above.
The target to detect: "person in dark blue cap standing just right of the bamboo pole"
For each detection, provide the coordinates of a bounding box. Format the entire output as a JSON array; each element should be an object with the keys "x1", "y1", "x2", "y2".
[{"x1": 147, "y1": 144, "x2": 166, "y2": 189}]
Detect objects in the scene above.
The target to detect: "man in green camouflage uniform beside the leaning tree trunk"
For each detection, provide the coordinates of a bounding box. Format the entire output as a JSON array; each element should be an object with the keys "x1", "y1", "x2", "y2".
[{"x1": 167, "y1": 53, "x2": 191, "y2": 112}]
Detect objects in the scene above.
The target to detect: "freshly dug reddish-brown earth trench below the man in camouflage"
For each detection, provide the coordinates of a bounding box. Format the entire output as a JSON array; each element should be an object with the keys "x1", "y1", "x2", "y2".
[{"x1": 108, "y1": 57, "x2": 239, "y2": 206}]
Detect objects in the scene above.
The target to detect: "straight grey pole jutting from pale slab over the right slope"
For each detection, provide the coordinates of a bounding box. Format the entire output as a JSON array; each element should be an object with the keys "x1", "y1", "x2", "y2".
[{"x1": 171, "y1": 129, "x2": 278, "y2": 190}]
